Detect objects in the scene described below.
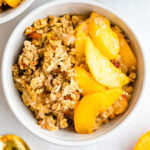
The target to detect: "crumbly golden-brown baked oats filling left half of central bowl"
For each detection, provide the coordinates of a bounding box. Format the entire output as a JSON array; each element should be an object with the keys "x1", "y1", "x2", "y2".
[{"x1": 12, "y1": 15, "x2": 85, "y2": 130}]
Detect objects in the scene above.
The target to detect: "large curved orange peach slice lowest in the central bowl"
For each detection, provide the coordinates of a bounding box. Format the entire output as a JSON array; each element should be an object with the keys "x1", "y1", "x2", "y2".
[{"x1": 74, "y1": 89, "x2": 123, "y2": 134}]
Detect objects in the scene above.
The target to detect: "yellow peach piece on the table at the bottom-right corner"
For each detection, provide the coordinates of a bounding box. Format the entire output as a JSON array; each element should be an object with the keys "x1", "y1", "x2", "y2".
[{"x1": 134, "y1": 131, "x2": 150, "y2": 150}]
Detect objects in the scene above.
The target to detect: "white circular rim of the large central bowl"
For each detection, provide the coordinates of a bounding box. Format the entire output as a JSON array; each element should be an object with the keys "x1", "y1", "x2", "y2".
[{"x1": 1, "y1": 0, "x2": 148, "y2": 146}]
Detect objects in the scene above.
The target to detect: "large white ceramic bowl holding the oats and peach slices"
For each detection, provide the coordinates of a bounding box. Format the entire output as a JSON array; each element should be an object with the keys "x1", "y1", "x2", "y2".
[{"x1": 2, "y1": 0, "x2": 145, "y2": 146}]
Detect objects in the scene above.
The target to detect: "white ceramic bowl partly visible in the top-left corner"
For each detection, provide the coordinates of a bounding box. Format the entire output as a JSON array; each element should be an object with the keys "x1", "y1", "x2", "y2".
[{"x1": 0, "y1": 0, "x2": 34, "y2": 24}]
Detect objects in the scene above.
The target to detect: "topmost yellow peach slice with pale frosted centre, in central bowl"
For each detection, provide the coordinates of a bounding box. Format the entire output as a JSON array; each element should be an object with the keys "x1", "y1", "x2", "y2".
[{"x1": 88, "y1": 12, "x2": 120, "y2": 59}]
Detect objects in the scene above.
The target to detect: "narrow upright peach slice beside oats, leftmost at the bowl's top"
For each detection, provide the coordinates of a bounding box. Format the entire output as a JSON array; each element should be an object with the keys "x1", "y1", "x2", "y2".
[{"x1": 75, "y1": 22, "x2": 87, "y2": 59}]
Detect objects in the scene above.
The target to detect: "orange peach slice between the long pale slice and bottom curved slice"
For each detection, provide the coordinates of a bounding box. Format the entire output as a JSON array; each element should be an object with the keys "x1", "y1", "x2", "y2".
[{"x1": 75, "y1": 66, "x2": 106, "y2": 95}]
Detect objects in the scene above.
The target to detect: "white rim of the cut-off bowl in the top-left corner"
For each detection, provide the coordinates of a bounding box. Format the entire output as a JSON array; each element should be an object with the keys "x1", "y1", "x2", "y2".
[{"x1": 0, "y1": 0, "x2": 34, "y2": 24}]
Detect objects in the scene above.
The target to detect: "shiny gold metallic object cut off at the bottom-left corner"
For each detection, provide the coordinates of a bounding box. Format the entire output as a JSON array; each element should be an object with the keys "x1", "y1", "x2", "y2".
[{"x1": 0, "y1": 135, "x2": 30, "y2": 150}]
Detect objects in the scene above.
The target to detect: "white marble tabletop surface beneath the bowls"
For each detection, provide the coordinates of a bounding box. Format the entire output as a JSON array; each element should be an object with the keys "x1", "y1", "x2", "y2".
[{"x1": 0, "y1": 0, "x2": 150, "y2": 150}]
